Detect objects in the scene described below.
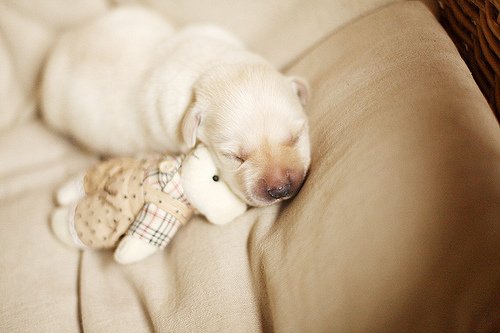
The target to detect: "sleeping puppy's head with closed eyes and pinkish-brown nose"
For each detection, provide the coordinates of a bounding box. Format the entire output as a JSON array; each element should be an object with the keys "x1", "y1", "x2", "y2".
[{"x1": 182, "y1": 64, "x2": 311, "y2": 206}]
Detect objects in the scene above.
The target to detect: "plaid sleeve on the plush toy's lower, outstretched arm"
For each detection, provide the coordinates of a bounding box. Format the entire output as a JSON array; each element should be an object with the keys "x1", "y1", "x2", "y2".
[{"x1": 127, "y1": 203, "x2": 182, "y2": 249}]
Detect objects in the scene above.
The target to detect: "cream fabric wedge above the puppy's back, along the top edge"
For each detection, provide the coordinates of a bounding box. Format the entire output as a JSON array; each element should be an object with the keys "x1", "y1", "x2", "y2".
[{"x1": 129, "y1": 0, "x2": 402, "y2": 68}]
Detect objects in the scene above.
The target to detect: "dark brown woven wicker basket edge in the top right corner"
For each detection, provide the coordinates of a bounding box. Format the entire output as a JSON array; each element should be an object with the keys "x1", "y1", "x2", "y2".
[{"x1": 438, "y1": 0, "x2": 500, "y2": 121}]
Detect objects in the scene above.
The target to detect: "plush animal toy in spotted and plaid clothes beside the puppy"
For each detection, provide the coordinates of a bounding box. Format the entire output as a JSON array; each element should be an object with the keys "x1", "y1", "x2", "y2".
[{"x1": 51, "y1": 145, "x2": 247, "y2": 264}]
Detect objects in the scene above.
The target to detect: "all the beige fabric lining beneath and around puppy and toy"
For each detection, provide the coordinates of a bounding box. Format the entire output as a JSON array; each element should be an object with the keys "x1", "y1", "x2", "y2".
[{"x1": 0, "y1": 0, "x2": 500, "y2": 332}]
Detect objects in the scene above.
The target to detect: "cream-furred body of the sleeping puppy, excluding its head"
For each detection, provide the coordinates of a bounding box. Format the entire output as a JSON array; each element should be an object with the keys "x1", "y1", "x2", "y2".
[{"x1": 42, "y1": 7, "x2": 252, "y2": 154}]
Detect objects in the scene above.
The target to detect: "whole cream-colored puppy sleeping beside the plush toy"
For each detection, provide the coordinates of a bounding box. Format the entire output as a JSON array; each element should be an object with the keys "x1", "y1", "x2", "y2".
[{"x1": 41, "y1": 7, "x2": 310, "y2": 206}]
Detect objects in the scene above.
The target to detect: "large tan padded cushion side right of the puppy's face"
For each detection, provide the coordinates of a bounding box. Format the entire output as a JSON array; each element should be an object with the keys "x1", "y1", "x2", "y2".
[{"x1": 251, "y1": 2, "x2": 500, "y2": 332}]
